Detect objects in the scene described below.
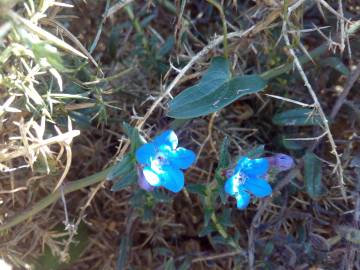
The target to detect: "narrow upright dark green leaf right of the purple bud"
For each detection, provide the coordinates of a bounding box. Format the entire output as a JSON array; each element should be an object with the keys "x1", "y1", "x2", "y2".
[{"x1": 304, "y1": 152, "x2": 322, "y2": 199}]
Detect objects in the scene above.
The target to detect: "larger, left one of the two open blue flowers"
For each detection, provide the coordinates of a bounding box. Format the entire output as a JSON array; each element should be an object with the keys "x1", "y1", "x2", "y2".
[{"x1": 135, "y1": 130, "x2": 195, "y2": 192}]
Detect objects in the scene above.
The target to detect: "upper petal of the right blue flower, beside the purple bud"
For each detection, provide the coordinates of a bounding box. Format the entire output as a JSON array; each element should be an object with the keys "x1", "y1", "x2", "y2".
[{"x1": 235, "y1": 157, "x2": 269, "y2": 177}]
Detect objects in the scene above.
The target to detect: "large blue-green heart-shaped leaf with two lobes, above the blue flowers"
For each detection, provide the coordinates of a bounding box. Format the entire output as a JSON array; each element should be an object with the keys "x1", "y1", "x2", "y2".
[{"x1": 168, "y1": 57, "x2": 266, "y2": 119}]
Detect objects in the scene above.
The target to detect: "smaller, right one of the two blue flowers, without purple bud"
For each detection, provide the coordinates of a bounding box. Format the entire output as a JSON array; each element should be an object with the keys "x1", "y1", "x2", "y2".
[{"x1": 225, "y1": 157, "x2": 272, "y2": 209}]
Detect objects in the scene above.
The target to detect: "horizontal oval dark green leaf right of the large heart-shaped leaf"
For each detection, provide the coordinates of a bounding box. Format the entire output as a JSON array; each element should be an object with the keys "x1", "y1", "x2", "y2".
[{"x1": 272, "y1": 108, "x2": 322, "y2": 126}]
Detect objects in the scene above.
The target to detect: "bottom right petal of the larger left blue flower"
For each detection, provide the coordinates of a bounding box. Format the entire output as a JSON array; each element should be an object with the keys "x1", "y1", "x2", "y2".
[{"x1": 160, "y1": 166, "x2": 185, "y2": 192}]
